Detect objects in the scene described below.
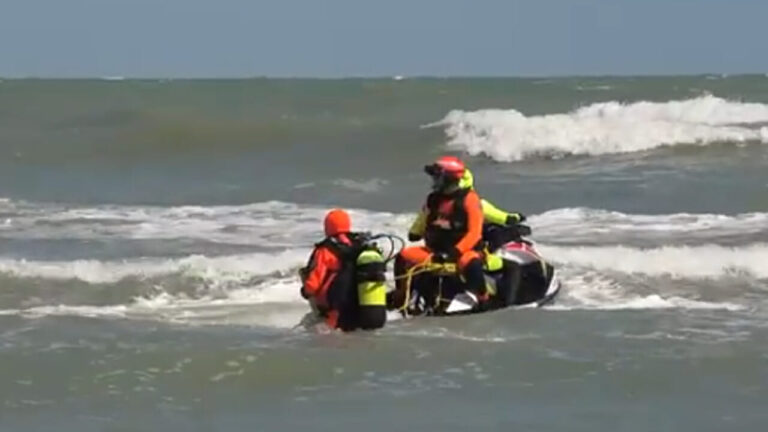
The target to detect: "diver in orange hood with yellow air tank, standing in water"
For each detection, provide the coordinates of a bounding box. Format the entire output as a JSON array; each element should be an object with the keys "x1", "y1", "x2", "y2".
[{"x1": 300, "y1": 209, "x2": 387, "y2": 331}]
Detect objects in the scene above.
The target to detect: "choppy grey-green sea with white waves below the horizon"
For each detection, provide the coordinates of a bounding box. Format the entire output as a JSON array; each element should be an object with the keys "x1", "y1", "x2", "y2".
[{"x1": 0, "y1": 75, "x2": 768, "y2": 432}]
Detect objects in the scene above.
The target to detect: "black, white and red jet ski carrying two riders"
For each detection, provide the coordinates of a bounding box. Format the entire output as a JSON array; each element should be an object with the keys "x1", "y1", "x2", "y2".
[{"x1": 399, "y1": 224, "x2": 561, "y2": 317}]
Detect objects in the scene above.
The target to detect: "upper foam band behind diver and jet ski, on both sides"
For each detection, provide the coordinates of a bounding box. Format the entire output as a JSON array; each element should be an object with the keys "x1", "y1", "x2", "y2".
[{"x1": 10, "y1": 197, "x2": 768, "y2": 248}]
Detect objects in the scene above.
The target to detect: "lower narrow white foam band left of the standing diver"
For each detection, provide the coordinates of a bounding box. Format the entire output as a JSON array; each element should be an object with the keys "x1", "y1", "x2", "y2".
[{"x1": 0, "y1": 249, "x2": 309, "y2": 283}]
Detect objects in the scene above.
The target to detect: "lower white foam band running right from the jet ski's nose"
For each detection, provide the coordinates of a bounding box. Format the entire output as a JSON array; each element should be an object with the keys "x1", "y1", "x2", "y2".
[{"x1": 539, "y1": 244, "x2": 768, "y2": 279}]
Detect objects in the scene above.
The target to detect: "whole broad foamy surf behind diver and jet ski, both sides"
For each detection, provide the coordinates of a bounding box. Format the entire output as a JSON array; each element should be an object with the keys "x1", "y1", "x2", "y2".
[{"x1": 0, "y1": 199, "x2": 768, "y2": 327}]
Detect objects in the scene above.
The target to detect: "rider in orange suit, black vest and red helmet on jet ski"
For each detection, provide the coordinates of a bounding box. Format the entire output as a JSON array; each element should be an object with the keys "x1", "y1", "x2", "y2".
[{"x1": 390, "y1": 156, "x2": 488, "y2": 307}]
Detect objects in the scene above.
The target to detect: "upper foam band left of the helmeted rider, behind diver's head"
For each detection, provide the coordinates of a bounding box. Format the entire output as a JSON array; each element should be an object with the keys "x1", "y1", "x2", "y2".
[{"x1": 0, "y1": 200, "x2": 409, "y2": 247}]
